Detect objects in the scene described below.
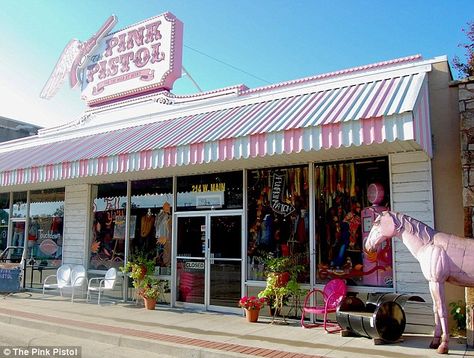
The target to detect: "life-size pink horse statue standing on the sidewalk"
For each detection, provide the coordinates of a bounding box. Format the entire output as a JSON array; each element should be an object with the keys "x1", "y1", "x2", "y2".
[{"x1": 364, "y1": 211, "x2": 474, "y2": 354}]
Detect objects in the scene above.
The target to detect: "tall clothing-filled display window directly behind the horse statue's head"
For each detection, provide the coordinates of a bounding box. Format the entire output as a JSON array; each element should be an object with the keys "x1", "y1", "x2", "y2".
[{"x1": 314, "y1": 158, "x2": 393, "y2": 287}]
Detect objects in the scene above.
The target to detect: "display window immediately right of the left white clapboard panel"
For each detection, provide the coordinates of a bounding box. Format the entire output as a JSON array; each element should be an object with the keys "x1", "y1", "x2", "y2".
[{"x1": 90, "y1": 182, "x2": 127, "y2": 270}]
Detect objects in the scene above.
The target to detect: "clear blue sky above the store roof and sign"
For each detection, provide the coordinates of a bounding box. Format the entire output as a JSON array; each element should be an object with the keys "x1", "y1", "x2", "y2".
[{"x1": 0, "y1": 0, "x2": 474, "y2": 127}]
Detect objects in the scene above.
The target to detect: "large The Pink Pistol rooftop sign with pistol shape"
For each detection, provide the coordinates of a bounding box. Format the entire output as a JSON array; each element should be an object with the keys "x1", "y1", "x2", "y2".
[{"x1": 47, "y1": 12, "x2": 183, "y2": 106}]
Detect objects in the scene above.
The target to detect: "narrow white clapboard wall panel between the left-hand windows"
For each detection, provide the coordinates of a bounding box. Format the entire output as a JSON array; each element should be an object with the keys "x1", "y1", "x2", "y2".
[{"x1": 63, "y1": 185, "x2": 90, "y2": 265}]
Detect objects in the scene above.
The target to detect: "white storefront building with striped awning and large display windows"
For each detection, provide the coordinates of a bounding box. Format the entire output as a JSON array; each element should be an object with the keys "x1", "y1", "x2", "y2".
[{"x1": 0, "y1": 14, "x2": 463, "y2": 311}]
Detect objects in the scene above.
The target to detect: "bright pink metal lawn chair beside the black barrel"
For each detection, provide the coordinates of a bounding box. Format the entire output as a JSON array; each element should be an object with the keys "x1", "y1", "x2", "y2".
[{"x1": 301, "y1": 278, "x2": 347, "y2": 333}]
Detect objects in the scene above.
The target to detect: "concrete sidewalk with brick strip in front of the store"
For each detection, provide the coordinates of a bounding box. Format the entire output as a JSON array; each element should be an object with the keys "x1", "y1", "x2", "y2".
[{"x1": 0, "y1": 292, "x2": 474, "y2": 358}]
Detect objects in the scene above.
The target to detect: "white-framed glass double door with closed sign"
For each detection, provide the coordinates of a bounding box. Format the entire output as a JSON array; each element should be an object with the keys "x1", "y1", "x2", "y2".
[{"x1": 175, "y1": 213, "x2": 242, "y2": 311}]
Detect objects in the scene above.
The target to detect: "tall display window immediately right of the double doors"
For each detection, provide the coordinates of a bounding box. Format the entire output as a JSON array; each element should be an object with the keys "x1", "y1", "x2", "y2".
[{"x1": 247, "y1": 166, "x2": 311, "y2": 283}]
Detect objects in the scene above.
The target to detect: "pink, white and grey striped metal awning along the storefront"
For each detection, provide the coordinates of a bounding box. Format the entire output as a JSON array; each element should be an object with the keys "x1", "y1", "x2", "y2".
[{"x1": 0, "y1": 72, "x2": 431, "y2": 186}]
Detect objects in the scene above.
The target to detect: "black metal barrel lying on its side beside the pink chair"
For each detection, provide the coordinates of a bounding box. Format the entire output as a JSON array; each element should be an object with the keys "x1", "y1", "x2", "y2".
[{"x1": 336, "y1": 297, "x2": 406, "y2": 342}]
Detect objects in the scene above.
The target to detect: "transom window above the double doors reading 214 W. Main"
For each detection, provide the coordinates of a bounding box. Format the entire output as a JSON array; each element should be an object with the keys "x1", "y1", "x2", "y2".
[{"x1": 176, "y1": 172, "x2": 243, "y2": 211}]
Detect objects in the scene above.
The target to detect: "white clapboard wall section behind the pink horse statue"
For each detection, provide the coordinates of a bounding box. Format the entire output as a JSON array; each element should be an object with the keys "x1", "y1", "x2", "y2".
[{"x1": 390, "y1": 152, "x2": 434, "y2": 334}]
